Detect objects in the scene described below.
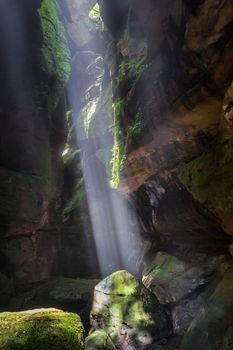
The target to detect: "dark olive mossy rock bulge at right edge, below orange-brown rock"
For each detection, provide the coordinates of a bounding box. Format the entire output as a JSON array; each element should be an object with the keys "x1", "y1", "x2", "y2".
[{"x1": 179, "y1": 138, "x2": 233, "y2": 216}]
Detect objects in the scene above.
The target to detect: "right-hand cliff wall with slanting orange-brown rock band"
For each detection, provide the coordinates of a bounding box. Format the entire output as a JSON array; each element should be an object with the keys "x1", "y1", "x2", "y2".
[{"x1": 103, "y1": 1, "x2": 233, "y2": 254}]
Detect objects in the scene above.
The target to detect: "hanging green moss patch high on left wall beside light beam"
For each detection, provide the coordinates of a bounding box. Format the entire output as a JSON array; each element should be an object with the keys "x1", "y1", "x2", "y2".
[{"x1": 38, "y1": 0, "x2": 71, "y2": 111}]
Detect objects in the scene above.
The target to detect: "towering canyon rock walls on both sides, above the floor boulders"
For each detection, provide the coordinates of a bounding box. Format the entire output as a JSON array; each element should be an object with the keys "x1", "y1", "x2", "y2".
[{"x1": 0, "y1": 0, "x2": 233, "y2": 298}]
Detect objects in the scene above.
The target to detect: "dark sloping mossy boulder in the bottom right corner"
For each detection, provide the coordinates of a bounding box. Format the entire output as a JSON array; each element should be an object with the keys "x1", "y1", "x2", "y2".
[{"x1": 180, "y1": 270, "x2": 233, "y2": 350}]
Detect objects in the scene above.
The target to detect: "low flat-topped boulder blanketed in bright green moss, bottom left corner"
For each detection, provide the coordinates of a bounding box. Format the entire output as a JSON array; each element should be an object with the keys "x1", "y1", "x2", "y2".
[{"x1": 0, "y1": 309, "x2": 84, "y2": 350}]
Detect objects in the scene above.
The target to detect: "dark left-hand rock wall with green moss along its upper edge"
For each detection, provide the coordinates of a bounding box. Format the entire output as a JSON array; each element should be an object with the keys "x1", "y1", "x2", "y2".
[{"x1": 0, "y1": 0, "x2": 70, "y2": 285}]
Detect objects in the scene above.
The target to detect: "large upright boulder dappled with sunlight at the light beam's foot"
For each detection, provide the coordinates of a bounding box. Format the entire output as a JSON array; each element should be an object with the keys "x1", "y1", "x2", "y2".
[{"x1": 91, "y1": 271, "x2": 170, "y2": 349}]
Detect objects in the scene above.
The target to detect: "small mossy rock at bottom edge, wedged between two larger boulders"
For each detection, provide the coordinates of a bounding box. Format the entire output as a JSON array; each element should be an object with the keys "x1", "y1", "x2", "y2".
[{"x1": 85, "y1": 330, "x2": 115, "y2": 350}]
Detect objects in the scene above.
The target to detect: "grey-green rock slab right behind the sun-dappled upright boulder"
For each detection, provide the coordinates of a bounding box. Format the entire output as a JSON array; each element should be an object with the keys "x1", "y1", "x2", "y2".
[{"x1": 143, "y1": 252, "x2": 223, "y2": 304}]
